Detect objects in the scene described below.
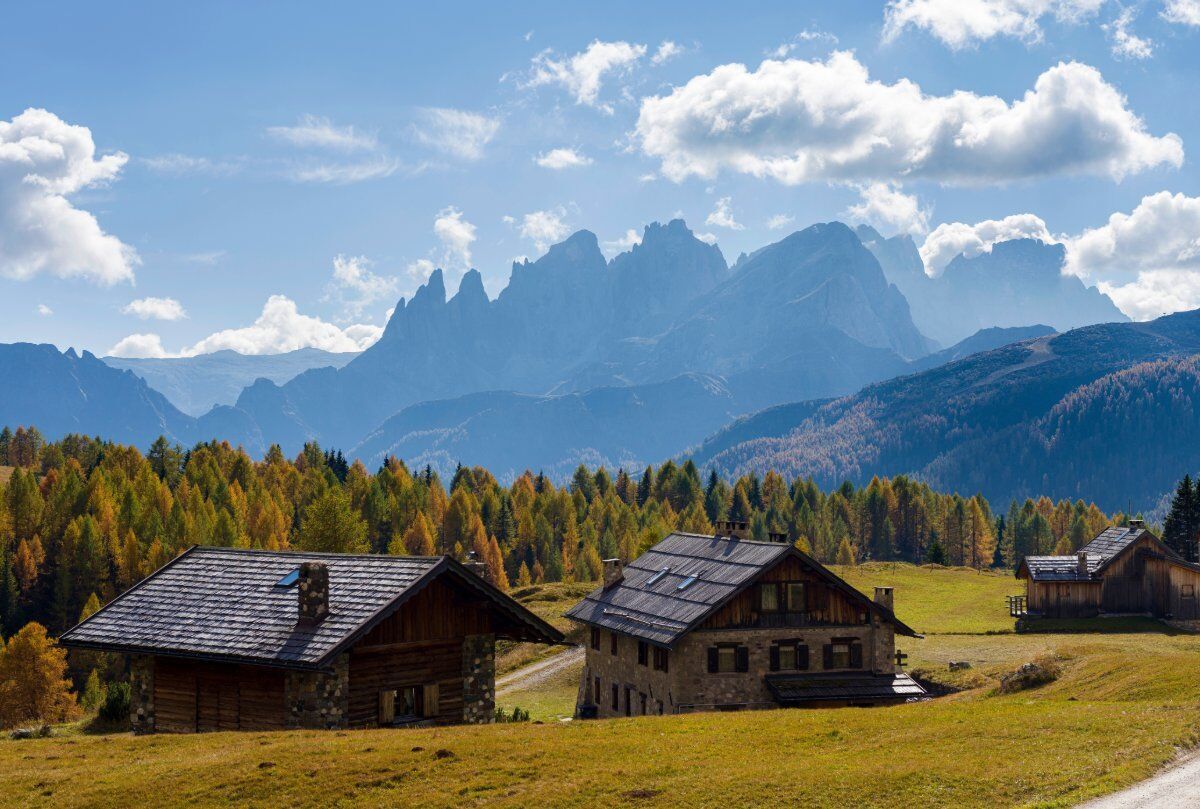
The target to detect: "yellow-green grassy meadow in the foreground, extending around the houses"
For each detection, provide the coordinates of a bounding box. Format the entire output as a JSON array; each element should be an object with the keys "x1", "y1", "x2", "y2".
[{"x1": 9, "y1": 567, "x2": 1200, "y2": 807}]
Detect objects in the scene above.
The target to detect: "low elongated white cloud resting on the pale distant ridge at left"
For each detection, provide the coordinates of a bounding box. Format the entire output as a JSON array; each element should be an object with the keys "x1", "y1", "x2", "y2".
[{"x1": 108, "y1": 295, "x2": 383, "y2": 358}]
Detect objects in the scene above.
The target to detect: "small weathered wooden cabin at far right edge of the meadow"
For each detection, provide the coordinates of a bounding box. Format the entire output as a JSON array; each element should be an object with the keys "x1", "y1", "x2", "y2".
[{"x1": 1016, "y1": 520, "x2": 1200, "y2": 621}]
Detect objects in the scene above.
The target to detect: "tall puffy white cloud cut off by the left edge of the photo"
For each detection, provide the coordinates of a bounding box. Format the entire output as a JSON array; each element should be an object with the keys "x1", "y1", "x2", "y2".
[{"x1": 0, "y1": 108, "x2": 140, "y2": 284}]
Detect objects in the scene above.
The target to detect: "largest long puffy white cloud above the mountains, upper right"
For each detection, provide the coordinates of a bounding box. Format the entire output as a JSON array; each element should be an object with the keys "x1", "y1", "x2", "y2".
[{"x1": 635, "y1": 52, "x2": 1183, "y2": 185}]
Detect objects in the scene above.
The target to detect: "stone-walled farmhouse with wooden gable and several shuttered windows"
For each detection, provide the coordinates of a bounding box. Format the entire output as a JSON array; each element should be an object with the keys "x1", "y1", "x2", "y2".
[{"x1": 566, "y1": 523, "x2": 925, "y2": 718}]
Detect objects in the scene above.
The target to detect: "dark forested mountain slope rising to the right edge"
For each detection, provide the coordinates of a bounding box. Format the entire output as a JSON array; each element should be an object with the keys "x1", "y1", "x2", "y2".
[{"x1": 694, "y1": 311, "x2": 1200, "y2": 510}]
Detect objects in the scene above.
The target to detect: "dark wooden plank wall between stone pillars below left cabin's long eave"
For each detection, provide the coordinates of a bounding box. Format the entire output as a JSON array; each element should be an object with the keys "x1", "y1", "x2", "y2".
[{"x1": 154, "y1": 657, "x2": 286, "y2": 733}]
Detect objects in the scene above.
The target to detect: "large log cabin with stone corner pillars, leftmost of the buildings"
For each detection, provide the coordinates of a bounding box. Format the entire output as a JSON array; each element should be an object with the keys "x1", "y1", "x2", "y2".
[{"x1": 61, "y1": 547, "x2": 563, "y2": 732}]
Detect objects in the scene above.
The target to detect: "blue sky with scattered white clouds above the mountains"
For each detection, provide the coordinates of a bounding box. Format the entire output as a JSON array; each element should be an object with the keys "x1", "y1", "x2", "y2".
[{"x1": 0, "y1": 0, "x2": 1200, "y2": 356}]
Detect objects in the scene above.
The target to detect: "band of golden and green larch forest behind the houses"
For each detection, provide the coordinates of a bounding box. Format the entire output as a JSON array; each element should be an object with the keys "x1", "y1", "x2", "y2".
[{"x1": 0, "y1": 429, "x2": 1121, "y2": 648}]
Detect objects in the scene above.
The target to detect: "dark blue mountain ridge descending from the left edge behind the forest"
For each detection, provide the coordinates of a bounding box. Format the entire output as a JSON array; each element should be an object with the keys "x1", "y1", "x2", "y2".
[{"x1": 0, "y1": 343, "x2": 264, "y2": 454}]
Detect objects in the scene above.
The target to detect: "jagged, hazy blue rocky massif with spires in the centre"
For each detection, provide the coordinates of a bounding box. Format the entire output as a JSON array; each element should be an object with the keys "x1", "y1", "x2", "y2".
[{"x1": 238, "y1": 220, "x2": 931, "y2": 451}]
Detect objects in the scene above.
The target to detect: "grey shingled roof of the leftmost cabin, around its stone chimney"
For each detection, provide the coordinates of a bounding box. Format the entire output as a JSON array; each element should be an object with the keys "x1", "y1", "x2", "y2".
[{"x1": 60, "y1": 546, "x2": 563, "y2": 670}]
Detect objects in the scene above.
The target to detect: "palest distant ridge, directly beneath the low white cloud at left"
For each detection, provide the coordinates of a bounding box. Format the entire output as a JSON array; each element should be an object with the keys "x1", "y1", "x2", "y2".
[{"x1": 102, "y1": 348, "x2": 358, "y2": 417}]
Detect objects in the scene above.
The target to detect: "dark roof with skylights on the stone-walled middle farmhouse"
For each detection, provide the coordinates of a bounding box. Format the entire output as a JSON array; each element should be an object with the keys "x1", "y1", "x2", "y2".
[{"x1": 566, "y1": 532, "x2": 916, "y2": 647}]
